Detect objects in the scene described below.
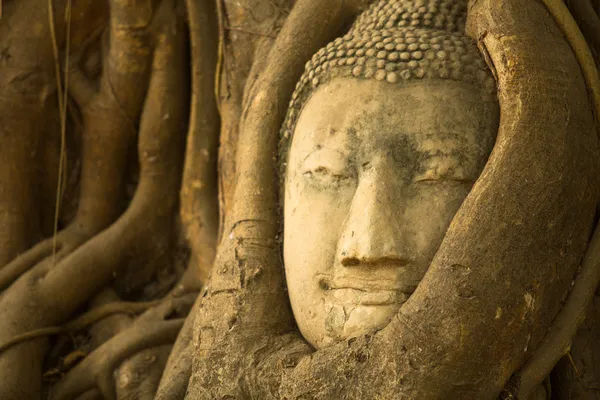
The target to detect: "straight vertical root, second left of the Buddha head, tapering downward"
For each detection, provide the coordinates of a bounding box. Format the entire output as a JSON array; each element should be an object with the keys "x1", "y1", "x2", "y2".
[{"x1": 180, "y1": 1, "x2": 219, "y2": 289}]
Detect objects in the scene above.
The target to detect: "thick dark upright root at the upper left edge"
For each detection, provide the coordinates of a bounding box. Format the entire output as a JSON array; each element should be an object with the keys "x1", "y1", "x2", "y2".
[{"x1": 0, "y1": 0, "x2": 72, "y2": 269}]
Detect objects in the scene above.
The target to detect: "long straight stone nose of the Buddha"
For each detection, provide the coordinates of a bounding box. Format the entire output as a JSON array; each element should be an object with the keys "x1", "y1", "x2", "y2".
[{"x1": 337, "y1": 160, "x2": 408, "y2": 267}]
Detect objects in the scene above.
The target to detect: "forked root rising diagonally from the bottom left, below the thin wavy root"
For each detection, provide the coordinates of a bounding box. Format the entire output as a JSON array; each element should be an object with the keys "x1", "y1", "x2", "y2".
[{"x1": 52, "y1": 294, "x2": 196, "y2": 400}]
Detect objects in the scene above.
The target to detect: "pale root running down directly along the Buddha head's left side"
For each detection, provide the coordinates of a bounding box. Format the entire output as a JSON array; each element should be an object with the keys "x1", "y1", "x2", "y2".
[{"x1": 188, "y1": 0, "x2": 364, "y2": 398}]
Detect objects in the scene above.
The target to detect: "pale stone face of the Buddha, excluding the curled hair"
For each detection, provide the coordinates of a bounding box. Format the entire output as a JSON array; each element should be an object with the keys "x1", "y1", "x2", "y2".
[{"x1": 284, "y1": 78, "x2": 498, "y2": 348}]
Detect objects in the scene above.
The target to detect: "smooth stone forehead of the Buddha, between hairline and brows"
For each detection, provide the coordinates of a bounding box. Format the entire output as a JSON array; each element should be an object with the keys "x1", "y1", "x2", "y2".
[{"x1": 294, "y1": 78, "x2": 496, "y2": 155}]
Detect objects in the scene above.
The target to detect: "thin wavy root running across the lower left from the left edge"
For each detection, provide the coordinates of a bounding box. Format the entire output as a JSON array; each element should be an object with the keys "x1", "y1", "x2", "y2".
[{"x1": 0, "y1": 301, "x2": 159, "y2": 354}]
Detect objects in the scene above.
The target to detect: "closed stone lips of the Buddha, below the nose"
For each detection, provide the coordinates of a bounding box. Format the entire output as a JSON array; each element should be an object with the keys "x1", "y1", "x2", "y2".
[{"x1": 319, "y1": 275, "x2": 415, "y2": 306}]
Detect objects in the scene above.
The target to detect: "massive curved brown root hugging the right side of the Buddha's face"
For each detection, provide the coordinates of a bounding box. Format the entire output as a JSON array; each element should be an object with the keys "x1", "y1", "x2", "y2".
[{"x1": 390, "y1": 0, "x2": 600, "y2": 398}]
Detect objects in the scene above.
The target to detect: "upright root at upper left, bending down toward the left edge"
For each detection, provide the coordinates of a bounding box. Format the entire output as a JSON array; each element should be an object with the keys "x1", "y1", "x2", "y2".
[{"x1": 0, "y1": 0, "x2": 151, "y2": 290}]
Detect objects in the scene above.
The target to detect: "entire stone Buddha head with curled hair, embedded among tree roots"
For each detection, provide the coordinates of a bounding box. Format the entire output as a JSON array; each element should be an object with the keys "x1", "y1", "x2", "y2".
[{"x1": 280, "y1": 0, "x2": 499, "y2": 348}]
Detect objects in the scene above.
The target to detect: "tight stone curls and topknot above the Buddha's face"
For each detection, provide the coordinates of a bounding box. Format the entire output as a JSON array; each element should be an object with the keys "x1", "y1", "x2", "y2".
[{"x1": 279, "y1": 0, "x2": 496, "y2": 176}]
